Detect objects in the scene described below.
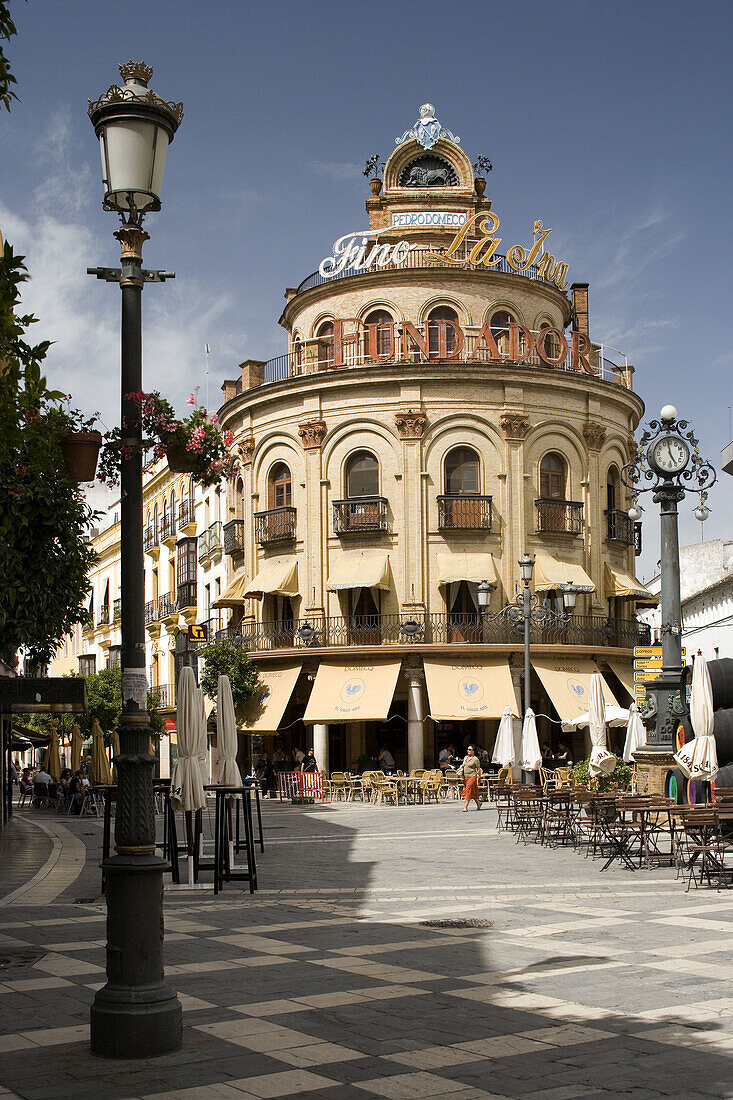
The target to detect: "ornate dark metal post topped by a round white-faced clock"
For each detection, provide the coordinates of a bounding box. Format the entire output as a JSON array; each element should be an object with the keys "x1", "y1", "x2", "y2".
[{"x1": 621, "y1": 405, "x2": 716, "y2": 752}]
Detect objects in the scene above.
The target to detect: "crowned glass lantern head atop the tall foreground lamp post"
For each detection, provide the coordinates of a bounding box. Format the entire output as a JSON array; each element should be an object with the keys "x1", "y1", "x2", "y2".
[{"x1": 89, "y1": 62, "x2": 183, "y2": 224}]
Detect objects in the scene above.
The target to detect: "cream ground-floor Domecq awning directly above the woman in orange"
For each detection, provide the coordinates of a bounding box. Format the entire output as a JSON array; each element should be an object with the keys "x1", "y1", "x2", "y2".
[{"x1": 423, "y1": 657, "x2": 519, "y2": 722}]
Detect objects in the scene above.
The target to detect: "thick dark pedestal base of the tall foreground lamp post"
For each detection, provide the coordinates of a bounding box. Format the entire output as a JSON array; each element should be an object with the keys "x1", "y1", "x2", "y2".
[{"x1": 91, "y1": 854, "x2": 183, "y2": 1058}]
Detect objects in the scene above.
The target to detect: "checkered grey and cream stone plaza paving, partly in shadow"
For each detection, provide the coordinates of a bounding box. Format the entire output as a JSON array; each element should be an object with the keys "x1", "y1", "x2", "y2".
[{"x1": 0, "y1": 803, "x2": 733, "y2": 1100}]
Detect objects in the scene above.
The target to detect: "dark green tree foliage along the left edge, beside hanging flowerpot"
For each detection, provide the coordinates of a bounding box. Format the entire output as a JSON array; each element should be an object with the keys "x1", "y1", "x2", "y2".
[{"x1": 0, "y1": 243, "x2": 94, "y2": 664}]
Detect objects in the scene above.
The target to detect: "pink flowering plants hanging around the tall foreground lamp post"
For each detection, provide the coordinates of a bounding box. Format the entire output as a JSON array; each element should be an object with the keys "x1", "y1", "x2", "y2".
[{"x1": 97, "y1": 389, "x2": 239, "y2": 486}]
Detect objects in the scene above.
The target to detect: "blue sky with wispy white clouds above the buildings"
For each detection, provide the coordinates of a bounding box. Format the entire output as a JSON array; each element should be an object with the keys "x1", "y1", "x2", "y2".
[{"x1": 0, "y1": 0, "x2": 733, "y2": 579}]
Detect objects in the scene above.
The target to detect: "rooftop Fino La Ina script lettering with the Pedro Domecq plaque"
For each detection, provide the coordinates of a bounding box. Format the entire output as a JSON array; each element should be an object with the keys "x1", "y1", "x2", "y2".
[{"x1": 318, "y1": 210, "x2": 568, "y2": 290}]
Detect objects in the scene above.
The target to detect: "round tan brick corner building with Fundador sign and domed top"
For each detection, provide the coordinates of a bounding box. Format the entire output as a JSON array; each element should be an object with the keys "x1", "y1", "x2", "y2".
[{"x1": 219, "y1": 105, "x2": 649, "y2": 770}]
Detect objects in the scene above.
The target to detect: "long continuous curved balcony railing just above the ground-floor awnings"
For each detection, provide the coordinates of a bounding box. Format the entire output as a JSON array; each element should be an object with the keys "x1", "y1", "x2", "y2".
[{"x1": 230, "y1": 612, "x2": 650, "y2": 652}]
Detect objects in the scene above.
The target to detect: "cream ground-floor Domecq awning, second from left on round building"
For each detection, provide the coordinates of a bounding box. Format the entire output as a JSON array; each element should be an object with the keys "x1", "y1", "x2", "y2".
[{"x1": 303, "y1": 661, "x2": 401, "y2": 722}]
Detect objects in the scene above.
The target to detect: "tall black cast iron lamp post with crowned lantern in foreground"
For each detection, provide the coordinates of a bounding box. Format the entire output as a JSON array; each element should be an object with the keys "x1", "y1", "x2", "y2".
[{"x1": 88, "y1": 62, "x2": 183, "y2": 1058}]
